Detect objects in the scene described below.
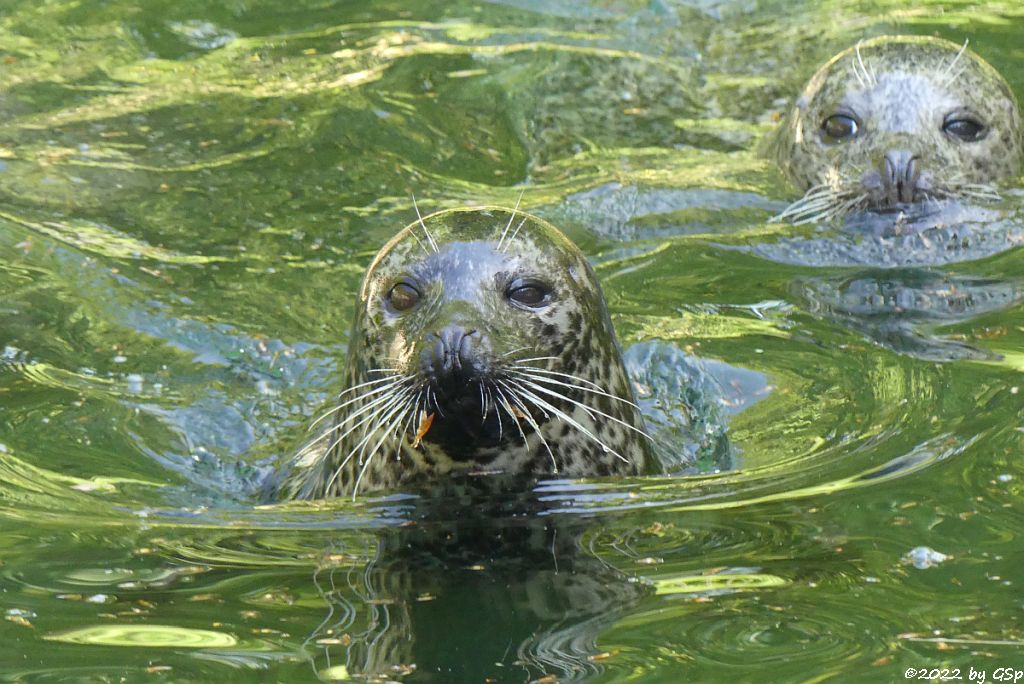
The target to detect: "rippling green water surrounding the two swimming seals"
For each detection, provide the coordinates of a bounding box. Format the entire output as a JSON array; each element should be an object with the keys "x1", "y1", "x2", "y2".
[{"x1": 0, "y1": 0, "x2": 1024, "y2": 682}]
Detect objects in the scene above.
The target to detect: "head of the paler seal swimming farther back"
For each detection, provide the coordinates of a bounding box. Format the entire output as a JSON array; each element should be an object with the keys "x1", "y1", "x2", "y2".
[{"x1": 769, "y1": 36, "x2": 1022, "y2": 223}]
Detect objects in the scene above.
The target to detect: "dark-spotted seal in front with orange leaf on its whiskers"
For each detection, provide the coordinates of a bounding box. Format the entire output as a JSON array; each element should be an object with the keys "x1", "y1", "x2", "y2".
[{"x1": 279, "y1": 202, "x2": 652, "y2": 499}]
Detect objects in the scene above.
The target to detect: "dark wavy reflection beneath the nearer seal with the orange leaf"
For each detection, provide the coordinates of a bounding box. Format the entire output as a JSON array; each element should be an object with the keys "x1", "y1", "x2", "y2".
[{"x1": 307, "y1": 502, "x2": 650, "y2": 681}]
